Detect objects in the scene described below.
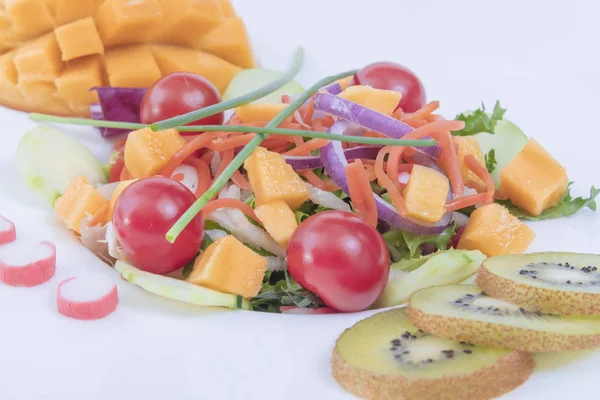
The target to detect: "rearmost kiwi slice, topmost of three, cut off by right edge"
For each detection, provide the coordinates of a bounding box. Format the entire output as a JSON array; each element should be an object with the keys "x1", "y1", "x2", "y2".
[{"x1": 476, "y1": 252, "x2": 600, "y2": 315}]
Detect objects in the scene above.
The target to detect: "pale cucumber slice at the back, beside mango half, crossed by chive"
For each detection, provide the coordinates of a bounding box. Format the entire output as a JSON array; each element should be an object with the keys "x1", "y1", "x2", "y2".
[{"x1": 223, "y1": 68, "x2": 304, "y2": 103}]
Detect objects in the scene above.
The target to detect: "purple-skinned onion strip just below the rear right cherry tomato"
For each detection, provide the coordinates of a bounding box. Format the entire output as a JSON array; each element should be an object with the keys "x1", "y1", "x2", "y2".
[{"x1": 313, "y1": 92, "x2": 441, "y2": 157}]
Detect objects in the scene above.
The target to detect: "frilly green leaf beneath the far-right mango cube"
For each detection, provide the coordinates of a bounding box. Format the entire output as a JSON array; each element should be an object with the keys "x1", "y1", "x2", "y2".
[{"x1": 496, "y1": 182, "x2": 600, "y2": 221}]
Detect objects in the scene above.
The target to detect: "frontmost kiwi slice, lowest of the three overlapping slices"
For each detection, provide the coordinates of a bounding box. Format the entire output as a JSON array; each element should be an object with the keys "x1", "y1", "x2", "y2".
[{"x1": 332, "y1": 308, "x2": 534, "y2": 400}]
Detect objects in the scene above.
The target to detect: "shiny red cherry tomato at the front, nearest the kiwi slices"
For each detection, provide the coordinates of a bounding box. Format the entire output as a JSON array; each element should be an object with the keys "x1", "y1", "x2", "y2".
[{"x1": 286, "y1": 211, "x2": 390, "y2": 312}]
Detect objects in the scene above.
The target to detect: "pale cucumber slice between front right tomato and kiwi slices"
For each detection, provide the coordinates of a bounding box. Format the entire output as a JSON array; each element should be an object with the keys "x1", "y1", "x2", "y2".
[{"x1": 375, "y1": 250, "x2": 486, "y2": 308}]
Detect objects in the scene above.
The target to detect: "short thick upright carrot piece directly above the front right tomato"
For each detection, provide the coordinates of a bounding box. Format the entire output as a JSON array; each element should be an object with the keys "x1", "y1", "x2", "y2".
[{"x1": 346, "y1": 159, "x2": 377, "y2": 227}]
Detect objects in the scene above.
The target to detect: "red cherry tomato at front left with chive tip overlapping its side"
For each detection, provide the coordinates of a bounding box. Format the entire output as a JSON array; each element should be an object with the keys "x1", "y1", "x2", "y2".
[{"x1": 113, "y1": 177, "x2": 204, "y2": 274}]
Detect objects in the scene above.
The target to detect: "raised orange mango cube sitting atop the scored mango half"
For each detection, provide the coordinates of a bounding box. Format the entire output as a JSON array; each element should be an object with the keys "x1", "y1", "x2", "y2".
[{"x1": 54, "y1": 17, "x2": 104, "y2": 61}]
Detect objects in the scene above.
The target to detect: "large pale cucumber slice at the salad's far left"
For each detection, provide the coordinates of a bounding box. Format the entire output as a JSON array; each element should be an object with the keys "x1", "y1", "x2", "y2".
[{"x1": 15, "y1": 127, "x2": 108, "y2": 205}]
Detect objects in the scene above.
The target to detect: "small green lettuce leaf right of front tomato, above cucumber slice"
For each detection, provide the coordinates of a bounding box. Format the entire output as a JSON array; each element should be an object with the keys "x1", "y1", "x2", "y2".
[{"x1": 383, "y1": 223, "x2": 456, "y2": 261}]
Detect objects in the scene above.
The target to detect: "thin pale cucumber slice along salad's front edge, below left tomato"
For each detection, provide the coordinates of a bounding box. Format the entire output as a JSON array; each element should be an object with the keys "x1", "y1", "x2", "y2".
[{"x1": 115, "y1": 261, "x2": 250, "y2": 310}]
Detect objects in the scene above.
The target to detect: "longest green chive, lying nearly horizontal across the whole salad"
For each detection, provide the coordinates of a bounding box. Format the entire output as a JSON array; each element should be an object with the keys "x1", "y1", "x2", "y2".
[{"x1": 29, "y1": 113, "x2": 436, "y2": 147}]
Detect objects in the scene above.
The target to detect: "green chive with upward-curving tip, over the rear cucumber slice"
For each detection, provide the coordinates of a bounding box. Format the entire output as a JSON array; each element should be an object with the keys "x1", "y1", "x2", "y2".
[{"x1": 150, "y1": 47, "x2": 304, "y2": 131}]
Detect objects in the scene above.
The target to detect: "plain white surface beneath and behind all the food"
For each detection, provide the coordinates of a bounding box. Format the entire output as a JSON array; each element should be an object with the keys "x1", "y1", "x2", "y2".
[{"x1": 0, "y1": 0, "x2": 600, "y2": 400}]
